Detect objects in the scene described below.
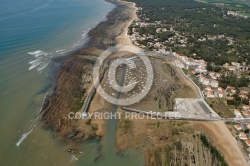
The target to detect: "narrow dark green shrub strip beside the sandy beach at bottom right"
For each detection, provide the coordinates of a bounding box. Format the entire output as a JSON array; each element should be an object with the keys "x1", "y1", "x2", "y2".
[{"x1": 200, "y1": 134, "x2": 228, "y2": 166}]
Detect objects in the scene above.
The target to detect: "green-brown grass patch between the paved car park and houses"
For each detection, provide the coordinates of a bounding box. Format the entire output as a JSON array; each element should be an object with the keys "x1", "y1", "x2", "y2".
[{"x1": 206, "y1": 98, "x2": 235, "y2": 118}]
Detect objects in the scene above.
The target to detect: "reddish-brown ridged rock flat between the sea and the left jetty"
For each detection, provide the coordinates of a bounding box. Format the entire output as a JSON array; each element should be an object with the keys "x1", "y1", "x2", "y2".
[{"x1": 42, "y1": 57, "x2": 93, "y2": 138}]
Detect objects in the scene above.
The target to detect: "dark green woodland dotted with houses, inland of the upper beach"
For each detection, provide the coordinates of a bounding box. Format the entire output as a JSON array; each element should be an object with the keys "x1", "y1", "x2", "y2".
[{"x1": 129, "y1": 0, "x2": 250, "y2": 65}]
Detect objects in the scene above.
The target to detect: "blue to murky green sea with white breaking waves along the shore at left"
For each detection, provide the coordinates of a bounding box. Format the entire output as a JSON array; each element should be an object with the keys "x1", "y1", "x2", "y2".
[{"x1": 0, "y1": 0, "x2": 114, "y2": 166}]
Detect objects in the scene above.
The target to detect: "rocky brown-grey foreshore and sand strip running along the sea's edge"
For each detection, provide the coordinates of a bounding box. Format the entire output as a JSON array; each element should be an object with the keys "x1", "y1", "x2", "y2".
[{"x1": 41, "y1": 0, "x2": 138, "y2": 144}]
